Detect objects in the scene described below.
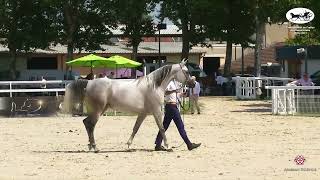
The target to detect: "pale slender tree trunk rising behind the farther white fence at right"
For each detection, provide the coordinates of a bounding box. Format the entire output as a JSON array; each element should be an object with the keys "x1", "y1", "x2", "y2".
[{"x1": 254, "y1": 12, "x2": 265, "y2": 77}]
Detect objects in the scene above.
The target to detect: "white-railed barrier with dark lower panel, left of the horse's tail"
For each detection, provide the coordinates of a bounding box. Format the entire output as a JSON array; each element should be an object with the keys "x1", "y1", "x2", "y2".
[{"x1": 0, "y1": 80, "x2": 71, "y2": 117}]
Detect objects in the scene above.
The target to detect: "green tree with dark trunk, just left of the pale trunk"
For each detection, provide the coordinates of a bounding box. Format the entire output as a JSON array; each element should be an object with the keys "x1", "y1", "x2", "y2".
[{"x1": 202, "y1": 0, "x2": 254, "y2": 76}]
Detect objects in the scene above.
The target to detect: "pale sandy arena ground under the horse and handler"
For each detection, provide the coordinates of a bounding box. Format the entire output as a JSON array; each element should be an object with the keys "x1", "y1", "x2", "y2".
[{"x1": 0, "y1": 97, "x2": 320, "y2": 180}]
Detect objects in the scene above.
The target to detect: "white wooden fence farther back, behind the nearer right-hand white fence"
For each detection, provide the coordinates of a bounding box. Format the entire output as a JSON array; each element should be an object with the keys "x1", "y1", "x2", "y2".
[{"x1": 232, "y1": 77, "x2": 293, "y2": 99}]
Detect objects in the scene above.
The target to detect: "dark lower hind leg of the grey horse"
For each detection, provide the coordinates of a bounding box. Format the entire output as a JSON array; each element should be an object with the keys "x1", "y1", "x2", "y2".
[{"x1": 83, "y1": 113, "x2": 100, "y2": 151}]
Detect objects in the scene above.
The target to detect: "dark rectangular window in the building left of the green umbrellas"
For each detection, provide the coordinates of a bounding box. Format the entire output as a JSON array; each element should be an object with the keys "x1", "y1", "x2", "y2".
[{"x1": 27, "y1": 57, "x2": 58, "y2": 69}]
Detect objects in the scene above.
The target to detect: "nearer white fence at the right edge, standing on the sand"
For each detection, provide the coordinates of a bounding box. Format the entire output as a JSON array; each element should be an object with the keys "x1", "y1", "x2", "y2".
[{"x1": 265, "y1": 86, "x2": 320, "y2": 115}]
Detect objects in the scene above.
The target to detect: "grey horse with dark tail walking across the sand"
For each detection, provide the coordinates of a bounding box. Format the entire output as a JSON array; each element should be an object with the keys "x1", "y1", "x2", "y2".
[{"x1": 64, "y1": 60, "x2": 195, "y2": 151}]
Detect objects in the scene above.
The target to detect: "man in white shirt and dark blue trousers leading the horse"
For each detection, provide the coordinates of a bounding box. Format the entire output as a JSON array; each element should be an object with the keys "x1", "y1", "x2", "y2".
[{"x1": 155, "y1": 80, "x2": 201, "y2": 151}]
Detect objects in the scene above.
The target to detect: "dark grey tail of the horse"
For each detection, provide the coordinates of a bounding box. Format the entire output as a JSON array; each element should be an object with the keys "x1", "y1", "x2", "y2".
[{"x1": 63, "y1": 79, "x2": 88, "y2": 113}]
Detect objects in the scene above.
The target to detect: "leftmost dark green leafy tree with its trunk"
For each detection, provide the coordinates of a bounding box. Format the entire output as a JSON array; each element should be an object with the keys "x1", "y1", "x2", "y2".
[{"x1": 0, "y1": 0, "x2": 53, "y2": 80}]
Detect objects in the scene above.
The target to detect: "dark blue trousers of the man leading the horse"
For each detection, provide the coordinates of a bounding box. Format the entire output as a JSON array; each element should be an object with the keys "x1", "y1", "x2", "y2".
[{"x1": 155, "y1": 104, "x2": 191, "y2": 146}]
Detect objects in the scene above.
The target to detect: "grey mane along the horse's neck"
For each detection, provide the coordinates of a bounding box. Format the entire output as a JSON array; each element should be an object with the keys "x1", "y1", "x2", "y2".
[{"x1": 146, "y1": 65, "x2": 172, "y2": 87}]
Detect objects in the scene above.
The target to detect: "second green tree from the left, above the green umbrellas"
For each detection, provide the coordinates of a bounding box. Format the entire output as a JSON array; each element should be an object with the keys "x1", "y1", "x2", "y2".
[{"x1": 51, "y1": 0, "x2": 116, "y2": 63}]
